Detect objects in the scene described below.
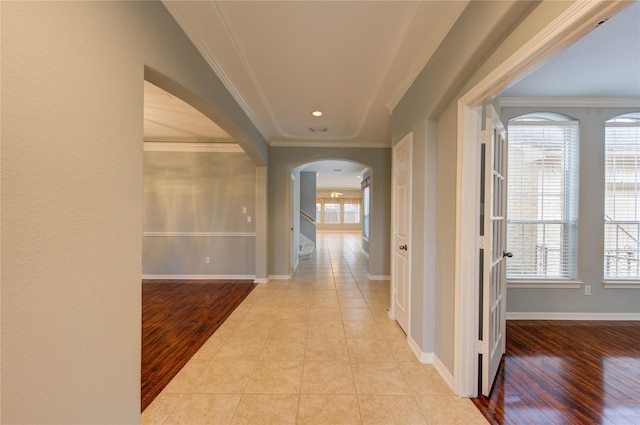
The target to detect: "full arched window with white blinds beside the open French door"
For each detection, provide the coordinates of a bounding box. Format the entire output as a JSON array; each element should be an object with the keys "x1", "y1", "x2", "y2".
[{"x1": 507, "y1": 113, "x2": 579, "y2": 279}]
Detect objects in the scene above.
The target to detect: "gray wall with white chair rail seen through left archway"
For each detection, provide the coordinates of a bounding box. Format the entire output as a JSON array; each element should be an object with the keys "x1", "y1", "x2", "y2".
[{"x1": 142, "y1": 152, "x2": 256, "y2": 278}]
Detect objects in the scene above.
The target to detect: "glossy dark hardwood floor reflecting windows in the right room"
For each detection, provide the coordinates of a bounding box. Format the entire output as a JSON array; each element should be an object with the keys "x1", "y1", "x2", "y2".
[{"x1": 473, "y1": 321, "x2": 640, "y2": 425}]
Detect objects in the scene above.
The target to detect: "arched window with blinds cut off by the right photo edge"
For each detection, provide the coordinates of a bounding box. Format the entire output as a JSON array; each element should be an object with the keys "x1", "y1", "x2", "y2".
[{"x1": 604, "y1": 113, "x2": 640, "y2": 280}]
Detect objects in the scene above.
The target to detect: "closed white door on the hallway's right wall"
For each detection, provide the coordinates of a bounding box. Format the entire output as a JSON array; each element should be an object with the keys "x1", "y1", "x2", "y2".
[{"x1": 391, "y1": 133, "x2": 413, "y2": 334}]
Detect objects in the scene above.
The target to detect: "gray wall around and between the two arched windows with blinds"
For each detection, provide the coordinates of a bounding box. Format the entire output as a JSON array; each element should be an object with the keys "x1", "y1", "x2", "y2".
[{"x1": 500, "y1": 107, "x2": 640, "y2": 313}]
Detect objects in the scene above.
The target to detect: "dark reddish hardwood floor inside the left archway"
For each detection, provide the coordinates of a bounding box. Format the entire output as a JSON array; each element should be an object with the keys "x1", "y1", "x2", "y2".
[{"x1": 141, "y1": 280, "x2": 256, "y2": 411}]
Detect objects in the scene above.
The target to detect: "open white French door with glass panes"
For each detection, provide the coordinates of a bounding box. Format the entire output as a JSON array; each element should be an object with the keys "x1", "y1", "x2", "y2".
[{"x1": 480, "y1": 106, "x2": 511, "y2": 396}]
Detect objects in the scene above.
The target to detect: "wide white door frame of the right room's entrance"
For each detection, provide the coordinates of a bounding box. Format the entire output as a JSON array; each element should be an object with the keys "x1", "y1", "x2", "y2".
[{"x1": 454, "y1": 1, "x2": 630, "y2": 397}]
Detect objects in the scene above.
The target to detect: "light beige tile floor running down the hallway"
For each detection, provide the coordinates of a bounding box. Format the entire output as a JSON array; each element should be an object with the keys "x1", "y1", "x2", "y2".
[{"x1": 142, "y1": 233, "x2": 487, "y2": 425}]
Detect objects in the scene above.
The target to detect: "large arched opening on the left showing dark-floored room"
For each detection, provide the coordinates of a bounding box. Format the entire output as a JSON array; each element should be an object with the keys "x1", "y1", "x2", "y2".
[{"x1": 141, "y1": 78, "x2": 266, "y2": 410}]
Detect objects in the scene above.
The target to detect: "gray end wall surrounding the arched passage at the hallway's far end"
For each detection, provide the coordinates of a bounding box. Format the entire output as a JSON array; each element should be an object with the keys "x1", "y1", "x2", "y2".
[{"x1": 269, "y1": 147, "x2": 391, "y2": 276}]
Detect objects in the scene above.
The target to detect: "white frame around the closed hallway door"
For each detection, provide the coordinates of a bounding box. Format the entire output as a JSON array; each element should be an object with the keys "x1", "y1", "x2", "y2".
[{"x1": 389, "y1": 131, "x2": 413, "y2": 332}]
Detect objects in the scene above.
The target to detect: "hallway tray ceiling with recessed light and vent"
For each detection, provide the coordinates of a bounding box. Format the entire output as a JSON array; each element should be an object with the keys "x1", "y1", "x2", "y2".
[{"x1": 164, "y1": 1, "x2": 467, "y2": 147}]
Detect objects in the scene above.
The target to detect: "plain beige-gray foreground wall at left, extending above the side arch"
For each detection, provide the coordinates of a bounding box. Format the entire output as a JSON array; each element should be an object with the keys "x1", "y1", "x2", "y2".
[{"x1": 0, "y1": 2, "x2": 268, "y2": 424}]
